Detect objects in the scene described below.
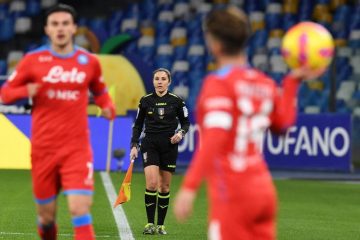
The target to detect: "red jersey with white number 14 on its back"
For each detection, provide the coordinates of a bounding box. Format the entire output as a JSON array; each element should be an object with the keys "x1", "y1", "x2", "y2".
[{"x1": 183, "y1": 66, "x2": 299, "y2": 193}]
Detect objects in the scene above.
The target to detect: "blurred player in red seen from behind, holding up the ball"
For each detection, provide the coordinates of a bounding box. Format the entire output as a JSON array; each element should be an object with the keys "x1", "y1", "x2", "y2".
[{"x1": 174, "y1": 7, "x2": 324, "y2": 240}]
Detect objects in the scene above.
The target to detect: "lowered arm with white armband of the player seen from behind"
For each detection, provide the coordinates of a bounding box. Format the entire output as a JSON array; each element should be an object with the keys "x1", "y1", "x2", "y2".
[{"x1": 174, "y1": 80, "x2": 235, "y2": 221}]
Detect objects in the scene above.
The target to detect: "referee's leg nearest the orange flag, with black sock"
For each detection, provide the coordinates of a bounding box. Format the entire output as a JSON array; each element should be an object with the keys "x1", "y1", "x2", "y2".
[{"x1": 141, "y1": 137, "x2": 159, "y2": 234}]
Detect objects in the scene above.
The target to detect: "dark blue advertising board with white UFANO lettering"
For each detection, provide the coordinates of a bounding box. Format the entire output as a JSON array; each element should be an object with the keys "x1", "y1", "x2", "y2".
[{"x1": 178, "y1": 114, "x2": 351, "y2": 171}]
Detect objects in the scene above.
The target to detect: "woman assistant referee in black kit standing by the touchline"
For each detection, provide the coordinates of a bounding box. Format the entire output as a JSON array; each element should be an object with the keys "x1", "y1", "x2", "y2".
[{"x1": 130, "y1": 68, "x2": 190, "y2": 234}]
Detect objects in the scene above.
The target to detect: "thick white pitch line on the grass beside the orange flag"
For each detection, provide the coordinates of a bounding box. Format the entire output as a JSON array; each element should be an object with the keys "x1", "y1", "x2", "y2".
[{"x1": 100, "y1": 172, "x2": 135, "y2": 240}]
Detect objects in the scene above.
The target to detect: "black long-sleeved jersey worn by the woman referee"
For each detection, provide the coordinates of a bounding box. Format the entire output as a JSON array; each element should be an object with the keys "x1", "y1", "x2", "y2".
[{"x1": 131, "y1": 92, "x2": 190, "y2": 146}]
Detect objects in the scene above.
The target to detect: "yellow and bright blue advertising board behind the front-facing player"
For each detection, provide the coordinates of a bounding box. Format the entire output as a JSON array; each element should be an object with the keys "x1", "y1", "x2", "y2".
[{"x1": 0, "y1": 114, "x2": 133, "y2": 170}]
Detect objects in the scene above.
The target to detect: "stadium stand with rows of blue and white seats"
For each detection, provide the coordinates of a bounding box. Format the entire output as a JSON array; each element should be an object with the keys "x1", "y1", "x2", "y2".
[{"x1": 0, "y1": 0, "x2": 360, "y2": 114}]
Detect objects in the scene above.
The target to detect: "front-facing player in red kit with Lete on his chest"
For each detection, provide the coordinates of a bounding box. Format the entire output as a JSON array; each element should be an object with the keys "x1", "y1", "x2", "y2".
[{"x1": 1, "y1": 4, "x2": 115, "y2": 240}]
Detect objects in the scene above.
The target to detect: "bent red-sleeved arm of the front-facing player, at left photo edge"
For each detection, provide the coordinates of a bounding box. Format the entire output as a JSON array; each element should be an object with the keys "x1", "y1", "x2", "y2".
[{"x1": 1, "y1": 56, "x2": 40, "y2": 104}]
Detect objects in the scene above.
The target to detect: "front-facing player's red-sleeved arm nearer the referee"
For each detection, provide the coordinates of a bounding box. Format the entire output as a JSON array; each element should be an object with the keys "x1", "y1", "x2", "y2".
[{"x1": 89, "y1": 56, "x2": 116, "y2": 120}]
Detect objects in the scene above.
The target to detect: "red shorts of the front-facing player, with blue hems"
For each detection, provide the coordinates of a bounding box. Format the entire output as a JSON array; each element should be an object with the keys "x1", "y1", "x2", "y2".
[{"x1": 31, "y1": 148, "x2": 94, "y2": 204}]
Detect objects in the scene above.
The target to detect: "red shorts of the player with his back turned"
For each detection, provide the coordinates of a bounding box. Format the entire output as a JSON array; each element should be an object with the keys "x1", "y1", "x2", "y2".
[{"x1": 208, "y1": 172, "x2": 277, "y2": 240}]
